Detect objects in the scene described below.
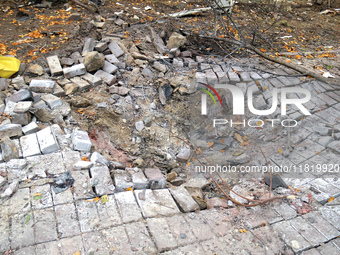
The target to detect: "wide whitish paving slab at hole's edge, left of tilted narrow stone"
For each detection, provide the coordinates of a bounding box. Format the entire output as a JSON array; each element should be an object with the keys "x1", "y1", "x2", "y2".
[{"x1": 135, "y1": 189, "x2": 180, "y2": 218}]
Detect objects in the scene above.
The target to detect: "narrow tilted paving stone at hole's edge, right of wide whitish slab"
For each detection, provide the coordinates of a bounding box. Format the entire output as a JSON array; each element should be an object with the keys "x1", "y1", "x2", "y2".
[{"x1": 169, "y1": 186, "x2": 199, "y2": 212}]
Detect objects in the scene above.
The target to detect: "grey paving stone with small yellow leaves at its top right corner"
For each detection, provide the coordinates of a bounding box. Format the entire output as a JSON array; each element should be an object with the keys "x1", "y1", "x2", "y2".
[{"x1": 75, "y1": 200, "x2": 100, "y2": 233}]
